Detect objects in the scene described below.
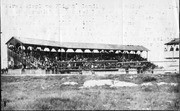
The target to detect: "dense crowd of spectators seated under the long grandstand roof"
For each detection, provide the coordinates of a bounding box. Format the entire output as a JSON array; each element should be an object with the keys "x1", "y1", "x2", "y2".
[{"x1": 9, "y1": 47, "x2": 155, "y2": 71}]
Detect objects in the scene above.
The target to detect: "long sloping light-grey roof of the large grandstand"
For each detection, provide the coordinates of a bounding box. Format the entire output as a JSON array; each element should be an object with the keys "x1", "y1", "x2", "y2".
[{"x1": 6, "y1": 37, "x2": 149, "y2": 51}]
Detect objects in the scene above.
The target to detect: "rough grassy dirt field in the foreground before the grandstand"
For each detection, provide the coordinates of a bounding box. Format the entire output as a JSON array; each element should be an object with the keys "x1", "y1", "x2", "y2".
[{"x1": 1, "y1": 74, "x2": 180, "y2": 110}]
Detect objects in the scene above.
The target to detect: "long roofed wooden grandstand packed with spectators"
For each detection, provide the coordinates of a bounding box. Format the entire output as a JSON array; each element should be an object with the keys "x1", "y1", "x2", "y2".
[{"x1": 6, "y1": 37, "x2": 155, "y2": 74}]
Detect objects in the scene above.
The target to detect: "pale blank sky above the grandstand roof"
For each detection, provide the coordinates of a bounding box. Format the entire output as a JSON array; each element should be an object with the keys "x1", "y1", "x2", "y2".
[{"x1": 1, "y1": 0, "x2": 179, "y2": 67}]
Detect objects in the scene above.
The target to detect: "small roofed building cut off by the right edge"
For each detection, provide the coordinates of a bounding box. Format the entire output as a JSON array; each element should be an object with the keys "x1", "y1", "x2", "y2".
[{"x1": 164, "y1": 38, "x2": 180, "y2": 72}]
